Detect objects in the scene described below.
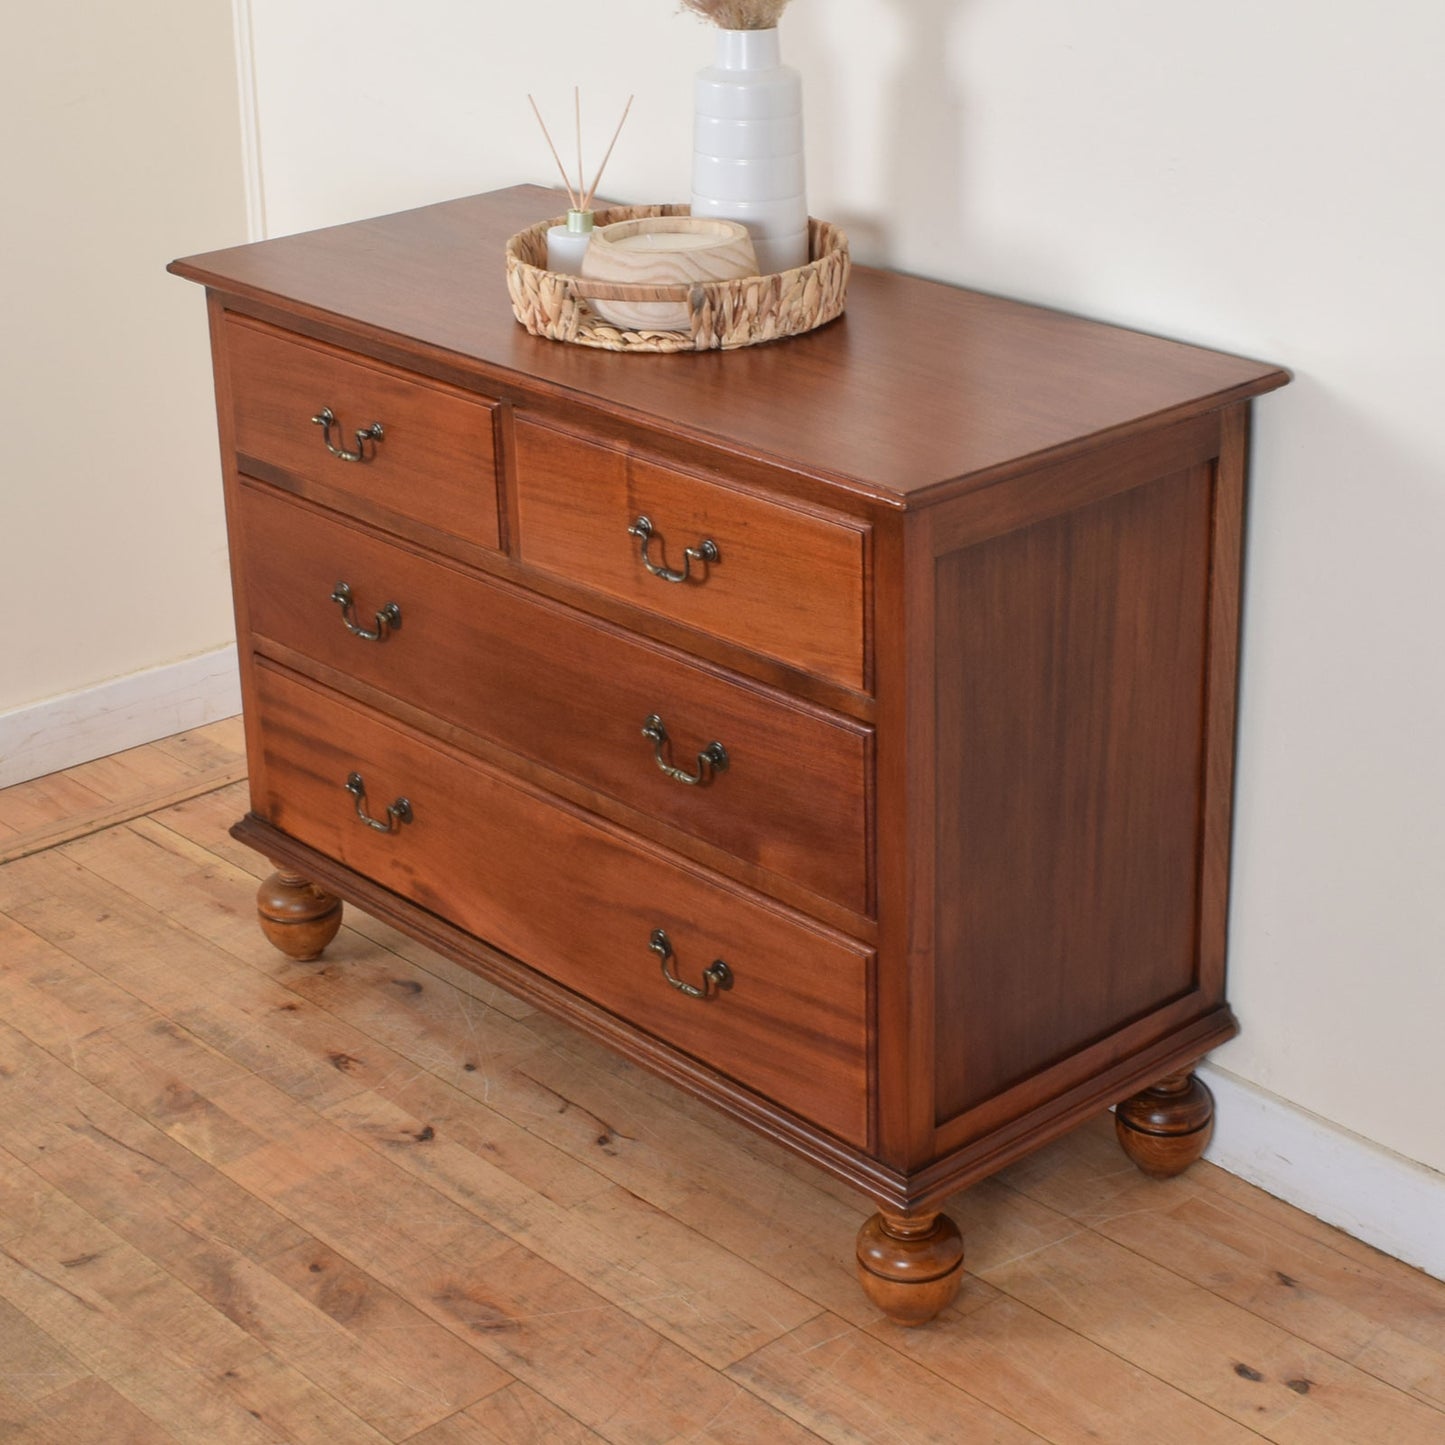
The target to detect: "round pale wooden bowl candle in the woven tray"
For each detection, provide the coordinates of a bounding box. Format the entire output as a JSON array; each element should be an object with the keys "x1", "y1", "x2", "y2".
[{"x1": 582, "y1": 215, "x2": 757, "y2": 331}]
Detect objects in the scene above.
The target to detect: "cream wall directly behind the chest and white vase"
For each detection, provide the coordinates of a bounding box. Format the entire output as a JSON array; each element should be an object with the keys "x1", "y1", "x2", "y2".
[{"x1": 251, "y1": 0, "x2": 1445, "y2": 1170}]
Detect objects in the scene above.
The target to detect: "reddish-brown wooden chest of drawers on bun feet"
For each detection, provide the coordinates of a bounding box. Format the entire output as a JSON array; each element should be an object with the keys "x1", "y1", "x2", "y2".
[{"x1": 172, "y1": 188, "x2": 1286, "y2": 1322}]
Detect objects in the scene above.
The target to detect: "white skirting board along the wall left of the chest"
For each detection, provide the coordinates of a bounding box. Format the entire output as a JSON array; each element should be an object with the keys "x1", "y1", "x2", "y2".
[{"x1": 0, "y1": 643, "x2": 241, "y2": 788}]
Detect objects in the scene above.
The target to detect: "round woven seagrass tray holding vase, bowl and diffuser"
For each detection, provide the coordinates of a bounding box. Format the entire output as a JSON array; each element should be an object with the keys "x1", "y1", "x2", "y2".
[{"x1": 507, "y1": 205, "x2": 850, "y2": 351}]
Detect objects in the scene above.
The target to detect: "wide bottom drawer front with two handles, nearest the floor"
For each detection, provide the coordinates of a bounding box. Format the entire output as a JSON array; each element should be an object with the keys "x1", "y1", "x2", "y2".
[{"x1": 253, "y1": 663, "x2": 871, "y2": 1146}]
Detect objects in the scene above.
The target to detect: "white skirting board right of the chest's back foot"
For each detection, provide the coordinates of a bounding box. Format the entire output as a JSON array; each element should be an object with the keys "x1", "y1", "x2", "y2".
[{"x1": 1199, "y1": 1064, "x2": 1445, "y2": 1279}]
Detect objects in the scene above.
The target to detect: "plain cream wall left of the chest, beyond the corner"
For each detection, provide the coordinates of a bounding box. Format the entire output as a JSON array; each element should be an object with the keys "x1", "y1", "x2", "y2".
[{"x1": 0, "y1": 0, "x2": 246, "y2": 714}]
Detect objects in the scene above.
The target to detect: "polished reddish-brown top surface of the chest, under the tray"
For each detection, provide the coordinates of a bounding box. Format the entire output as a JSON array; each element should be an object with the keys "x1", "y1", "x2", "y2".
[{"x1": 172, "y1": 186, "x2": 1287, "y2": 504}]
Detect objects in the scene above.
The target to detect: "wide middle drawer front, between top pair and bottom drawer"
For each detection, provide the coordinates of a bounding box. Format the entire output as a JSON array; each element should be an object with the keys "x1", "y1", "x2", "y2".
[{"x1": 236, "y1": 483, "x2": 873, "y2": 913}]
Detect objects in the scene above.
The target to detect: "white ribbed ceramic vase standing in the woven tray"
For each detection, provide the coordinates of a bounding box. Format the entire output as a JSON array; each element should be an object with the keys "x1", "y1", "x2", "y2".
[{"x1": 692, "y1": 29, "x2": 809, "y2": 276}]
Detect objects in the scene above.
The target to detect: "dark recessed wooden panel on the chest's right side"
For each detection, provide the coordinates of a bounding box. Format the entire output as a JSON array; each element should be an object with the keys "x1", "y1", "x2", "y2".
[{"x1": 936, "y1": 468, "x2": 1217, "y2": 1121}]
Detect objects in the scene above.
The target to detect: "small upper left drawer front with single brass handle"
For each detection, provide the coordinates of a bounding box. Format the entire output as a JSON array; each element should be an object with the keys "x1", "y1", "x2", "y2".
[{"x1": 225, "y1": 316, "x2": 499, "y2": 549}]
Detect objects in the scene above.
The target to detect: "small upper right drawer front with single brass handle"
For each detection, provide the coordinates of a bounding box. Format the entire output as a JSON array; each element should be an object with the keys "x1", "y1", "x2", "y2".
[{"x1": 516, "y1": 418, "x2": 867, "y2": 689}]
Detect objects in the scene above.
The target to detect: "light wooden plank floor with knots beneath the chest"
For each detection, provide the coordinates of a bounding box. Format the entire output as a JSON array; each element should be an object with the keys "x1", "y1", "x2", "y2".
[{"x1": 0, "y1": 723, "x2": 1445, "y2": 1445}]
